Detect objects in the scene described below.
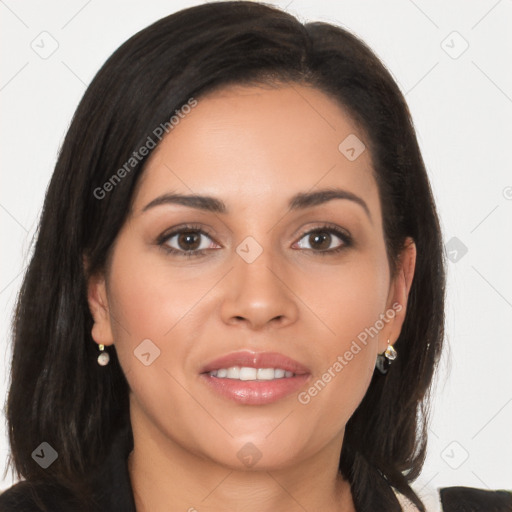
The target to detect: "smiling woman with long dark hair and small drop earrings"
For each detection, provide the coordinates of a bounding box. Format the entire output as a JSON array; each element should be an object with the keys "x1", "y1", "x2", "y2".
[{"x1": 0, "y1": 2, "x2": 507, "y2": 512}]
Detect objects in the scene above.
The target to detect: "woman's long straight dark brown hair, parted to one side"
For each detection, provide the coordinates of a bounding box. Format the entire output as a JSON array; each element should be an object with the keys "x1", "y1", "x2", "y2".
[{"x1": 2, "y1": 1, "x2": 445, "y2": 511}]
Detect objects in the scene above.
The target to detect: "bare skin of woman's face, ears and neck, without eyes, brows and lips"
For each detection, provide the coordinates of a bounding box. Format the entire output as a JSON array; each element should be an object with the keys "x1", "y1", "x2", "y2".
[{"x1": 89, "y1": 84, "x2": 416, "y2": 512}]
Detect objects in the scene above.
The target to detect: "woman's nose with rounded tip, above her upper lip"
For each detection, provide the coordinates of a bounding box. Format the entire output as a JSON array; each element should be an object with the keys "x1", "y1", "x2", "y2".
[{"x1": 221, "y1": 250, "x2": 299, "y2": 330}]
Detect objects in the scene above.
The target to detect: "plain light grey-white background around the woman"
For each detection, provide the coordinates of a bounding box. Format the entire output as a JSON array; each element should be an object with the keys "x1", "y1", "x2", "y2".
[{"x1": 0, "y1": 0, "x2": 512, "y2": 511}]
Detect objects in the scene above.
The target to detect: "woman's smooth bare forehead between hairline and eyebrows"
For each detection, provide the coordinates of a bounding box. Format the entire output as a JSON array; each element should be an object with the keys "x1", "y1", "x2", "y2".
[{"x1": 134, "y1": 84, "x2": 378, "y2": 218}]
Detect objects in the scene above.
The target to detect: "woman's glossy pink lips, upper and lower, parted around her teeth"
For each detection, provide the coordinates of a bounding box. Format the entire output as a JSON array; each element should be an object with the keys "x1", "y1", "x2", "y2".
[{"x1": 200, "y1": 351, "x2": 311, "y2": 405}]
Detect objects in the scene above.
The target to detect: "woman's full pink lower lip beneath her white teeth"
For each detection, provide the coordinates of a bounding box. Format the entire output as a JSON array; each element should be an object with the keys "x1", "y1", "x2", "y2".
[{"x1": 201, "y1": 373, "x2": 309, "y2": 405}]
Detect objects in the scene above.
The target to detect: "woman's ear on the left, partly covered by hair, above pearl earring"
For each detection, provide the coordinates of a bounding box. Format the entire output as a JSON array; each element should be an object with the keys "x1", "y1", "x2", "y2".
[{"x1": 84, "y1": 260, "x2": 114, "y2": 345}]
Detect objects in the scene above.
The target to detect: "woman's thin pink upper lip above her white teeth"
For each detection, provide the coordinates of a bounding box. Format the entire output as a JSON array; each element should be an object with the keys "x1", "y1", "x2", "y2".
[{"x1": 201, "y1": 350, "x2": 310, "y2": 375}]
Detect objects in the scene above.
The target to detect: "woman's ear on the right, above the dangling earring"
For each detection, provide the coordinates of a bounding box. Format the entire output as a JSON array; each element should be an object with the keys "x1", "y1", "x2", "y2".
[{"x1": 378, "y1": 237, "x2": 416, "y2": 354}]
